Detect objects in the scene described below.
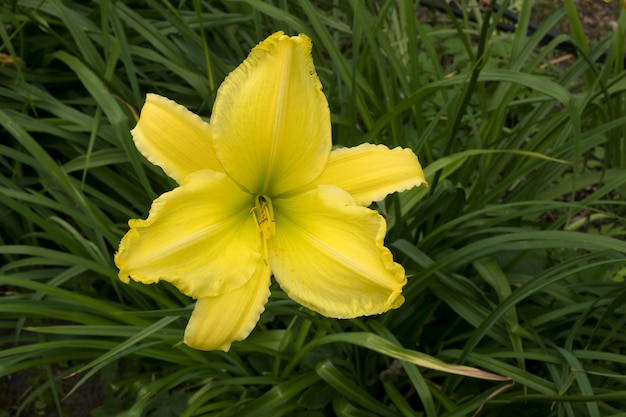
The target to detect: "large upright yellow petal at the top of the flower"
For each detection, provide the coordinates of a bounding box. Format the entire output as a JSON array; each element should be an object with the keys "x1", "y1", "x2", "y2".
[{"x1": 211, "y1": 32, "x2": 331, "y2": 196}]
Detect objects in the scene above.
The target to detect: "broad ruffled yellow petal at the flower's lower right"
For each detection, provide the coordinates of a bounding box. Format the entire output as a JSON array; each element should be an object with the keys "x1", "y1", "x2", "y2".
[{"x1": 269, "y1": 185, "x2": 406, "y2": 318}]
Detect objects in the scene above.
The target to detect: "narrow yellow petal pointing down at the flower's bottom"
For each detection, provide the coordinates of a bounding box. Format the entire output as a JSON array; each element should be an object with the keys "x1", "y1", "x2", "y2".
[{"x1": 184, "y1": 262, "x2": 271, "y2": 352}]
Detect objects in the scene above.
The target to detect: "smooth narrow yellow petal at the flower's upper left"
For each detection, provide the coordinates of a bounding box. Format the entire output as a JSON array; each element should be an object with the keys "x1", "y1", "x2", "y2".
[{"x1": 131, "y1": 94, "x2": 224, "y2": 184}]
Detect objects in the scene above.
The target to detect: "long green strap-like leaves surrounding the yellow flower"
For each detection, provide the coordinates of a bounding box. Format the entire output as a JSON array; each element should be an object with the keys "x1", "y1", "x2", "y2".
[{"x1": 0, "y1": 0, "x2": 626, "y2": 417}]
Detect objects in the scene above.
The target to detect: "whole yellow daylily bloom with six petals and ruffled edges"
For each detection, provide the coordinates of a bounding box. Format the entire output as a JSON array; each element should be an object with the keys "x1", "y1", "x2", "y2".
[{"x1": 115, "y1": 32, "x2": 425, "y2": 351}]
